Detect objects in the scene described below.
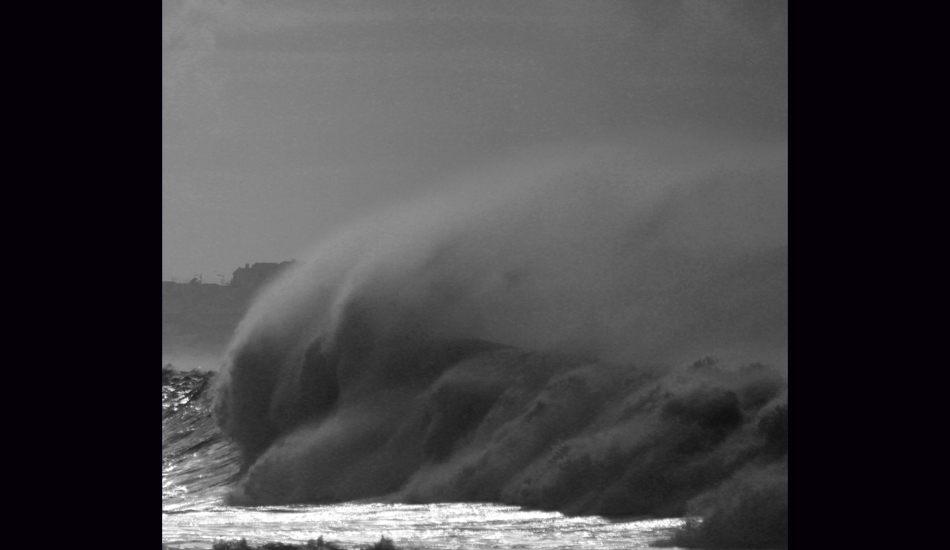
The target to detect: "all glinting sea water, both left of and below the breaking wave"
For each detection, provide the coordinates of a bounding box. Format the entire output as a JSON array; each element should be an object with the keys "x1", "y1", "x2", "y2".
[{"x1": 162, "y1": 371, "x2": 683, "y2": 550}]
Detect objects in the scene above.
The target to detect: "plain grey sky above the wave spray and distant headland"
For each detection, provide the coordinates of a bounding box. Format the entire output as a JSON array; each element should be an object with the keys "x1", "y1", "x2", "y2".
[{"x1": 162, "y1": 0, "x2": 788, "y2": 282}]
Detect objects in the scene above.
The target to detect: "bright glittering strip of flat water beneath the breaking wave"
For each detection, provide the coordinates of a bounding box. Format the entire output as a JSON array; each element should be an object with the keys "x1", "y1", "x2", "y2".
[{"x1": 162, "y1": 503, "x2": 683, "y2": 550}]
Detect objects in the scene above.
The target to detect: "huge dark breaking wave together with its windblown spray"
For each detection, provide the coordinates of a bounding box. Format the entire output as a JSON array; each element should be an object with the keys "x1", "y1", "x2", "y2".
[{"x1": 214, "y1": 140, "x2": 788, "y2": 545}]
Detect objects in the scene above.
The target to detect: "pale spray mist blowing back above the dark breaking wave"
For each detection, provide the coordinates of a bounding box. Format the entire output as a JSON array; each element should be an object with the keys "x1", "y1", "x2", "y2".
[{"x1": 233, "y1": 133, "x2": 788, "y2": 378}]
